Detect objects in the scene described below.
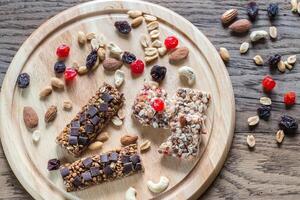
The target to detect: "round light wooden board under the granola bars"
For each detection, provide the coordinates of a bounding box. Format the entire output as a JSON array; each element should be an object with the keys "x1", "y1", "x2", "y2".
[{"x1": 0, "y1": 0, "x2": 235, "y2": 200}]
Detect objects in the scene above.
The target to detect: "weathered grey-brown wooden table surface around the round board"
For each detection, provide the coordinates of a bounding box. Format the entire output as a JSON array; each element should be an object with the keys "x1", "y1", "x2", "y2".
[{"x1": 0, "y1": 0, "x2": 300, "y2": 200}]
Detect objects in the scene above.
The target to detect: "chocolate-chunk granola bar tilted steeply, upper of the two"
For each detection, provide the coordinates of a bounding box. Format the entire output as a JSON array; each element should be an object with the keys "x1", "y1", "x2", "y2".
[{"x1": 56, "y1": 83, "x2": 124, "y2": 156}]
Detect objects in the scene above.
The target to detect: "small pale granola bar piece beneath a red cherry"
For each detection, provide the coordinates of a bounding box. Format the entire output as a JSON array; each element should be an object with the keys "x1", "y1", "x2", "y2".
[{"x1": 132, "y1": 83, "x2": 170, "y2": 128}]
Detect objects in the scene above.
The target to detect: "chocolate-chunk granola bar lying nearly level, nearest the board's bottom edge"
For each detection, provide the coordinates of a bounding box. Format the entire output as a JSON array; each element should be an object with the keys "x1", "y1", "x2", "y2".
[{"x1": 60, "y1": 144, "x2": 144, "y2": 192}]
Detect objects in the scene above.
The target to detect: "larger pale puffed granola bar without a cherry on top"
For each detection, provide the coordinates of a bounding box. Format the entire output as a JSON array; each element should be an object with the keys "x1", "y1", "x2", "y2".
[{"x1": 158, "y1": 88, "x2": 210, "y2": 158}]
